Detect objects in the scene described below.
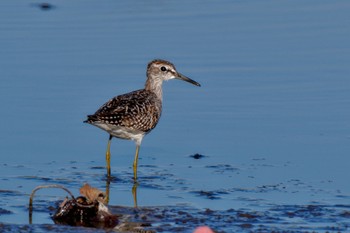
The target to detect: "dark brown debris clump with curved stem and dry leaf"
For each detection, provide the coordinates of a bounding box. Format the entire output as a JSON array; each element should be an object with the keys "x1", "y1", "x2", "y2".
[{"x1": 29, "y1": 184, "x2": 154, "y2": 233}]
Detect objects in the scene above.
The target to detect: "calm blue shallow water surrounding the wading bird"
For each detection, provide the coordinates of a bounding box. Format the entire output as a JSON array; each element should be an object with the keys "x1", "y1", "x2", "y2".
[{"x1": 0, "y1": 1, "x2": 350, "y2": 232}]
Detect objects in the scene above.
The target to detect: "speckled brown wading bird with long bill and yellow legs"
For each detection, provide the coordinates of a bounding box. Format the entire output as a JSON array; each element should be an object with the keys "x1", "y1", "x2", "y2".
[{"x1": 84, "y1": 59, "x2": 201, "y2": 182}]
